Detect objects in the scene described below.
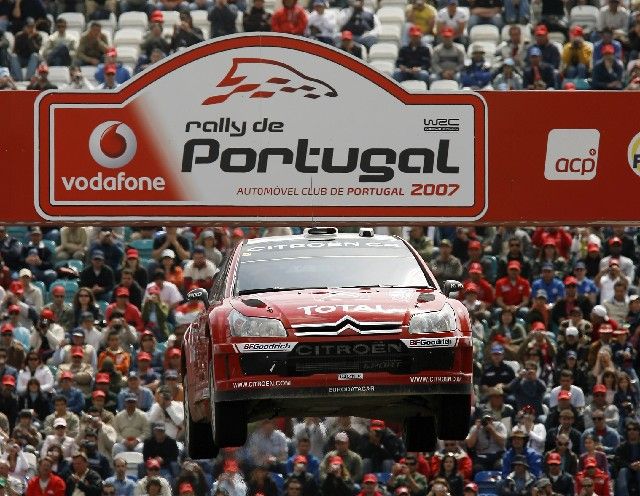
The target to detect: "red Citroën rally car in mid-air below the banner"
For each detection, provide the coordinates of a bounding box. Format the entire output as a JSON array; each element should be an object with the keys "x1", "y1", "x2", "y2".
[{"x1": 182, "y1": 227, "x2": 472, "y2": 458}]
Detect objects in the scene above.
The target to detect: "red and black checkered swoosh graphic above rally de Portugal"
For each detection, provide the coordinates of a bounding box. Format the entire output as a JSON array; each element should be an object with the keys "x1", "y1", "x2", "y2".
[{"x1": 202, "y1": 58, "x2": 338, "y2": 105}]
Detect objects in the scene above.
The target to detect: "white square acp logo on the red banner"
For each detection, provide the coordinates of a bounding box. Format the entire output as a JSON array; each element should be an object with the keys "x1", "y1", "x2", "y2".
[{"x1": 544, "y1": 129, "x2": 600, "y2": 181}]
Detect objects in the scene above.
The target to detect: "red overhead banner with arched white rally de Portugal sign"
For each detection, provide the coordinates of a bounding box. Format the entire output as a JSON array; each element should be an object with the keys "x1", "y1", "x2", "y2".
[{"x1": 0, "y1": 33, "x2": 640, "y2": 225}]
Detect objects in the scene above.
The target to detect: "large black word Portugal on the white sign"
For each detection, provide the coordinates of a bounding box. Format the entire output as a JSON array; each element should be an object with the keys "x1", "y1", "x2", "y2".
[{"x1": 182, "y1": 138, "x2": 460, "y2": 183}]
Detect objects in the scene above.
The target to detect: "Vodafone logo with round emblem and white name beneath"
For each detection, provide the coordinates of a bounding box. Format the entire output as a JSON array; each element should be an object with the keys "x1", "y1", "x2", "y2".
[{"x1": 61, "y1": 121, "x2": 166, "y2": 191}]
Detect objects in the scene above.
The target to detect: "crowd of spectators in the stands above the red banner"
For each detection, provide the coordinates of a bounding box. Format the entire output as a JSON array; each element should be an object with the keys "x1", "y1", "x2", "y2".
[{"x1": 0, "y1": 0, "x2": 640, "y2": 90}]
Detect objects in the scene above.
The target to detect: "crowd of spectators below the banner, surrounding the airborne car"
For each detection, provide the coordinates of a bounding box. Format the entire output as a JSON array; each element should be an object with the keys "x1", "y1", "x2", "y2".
[{"x1": 0, "y1": 226, "x2": 640, "y2": 496}]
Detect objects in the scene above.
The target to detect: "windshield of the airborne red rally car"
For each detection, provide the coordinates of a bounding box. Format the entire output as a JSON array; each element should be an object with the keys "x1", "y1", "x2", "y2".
[{"x1": 235, "y1": 238, "x2": 435, "y2": 294}]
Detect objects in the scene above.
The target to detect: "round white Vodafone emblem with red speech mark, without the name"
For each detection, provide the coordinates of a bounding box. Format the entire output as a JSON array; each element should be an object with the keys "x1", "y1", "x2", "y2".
[{"x1": 89, "y1": 121, "x2": 138, "y2": 169}]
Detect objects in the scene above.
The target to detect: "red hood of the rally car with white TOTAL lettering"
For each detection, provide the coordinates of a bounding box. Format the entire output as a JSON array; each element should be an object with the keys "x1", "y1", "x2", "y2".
[{"x1": 230, "y1": 288, "x2": 446, "y2": 332}]
